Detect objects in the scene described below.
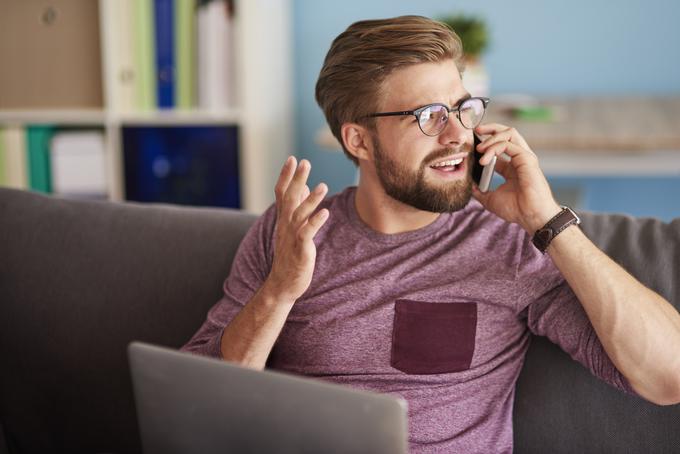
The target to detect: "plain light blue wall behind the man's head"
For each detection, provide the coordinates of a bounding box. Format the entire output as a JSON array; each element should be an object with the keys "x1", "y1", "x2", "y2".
[{"x1": 293, "y1": 0, "x2": 680, "y2": 218}]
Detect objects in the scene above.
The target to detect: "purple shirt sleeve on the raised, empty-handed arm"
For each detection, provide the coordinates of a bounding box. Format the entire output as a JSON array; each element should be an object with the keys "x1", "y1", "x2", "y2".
[{"x1": 180, "y1": 205, "x2": 276, "y2": 358}]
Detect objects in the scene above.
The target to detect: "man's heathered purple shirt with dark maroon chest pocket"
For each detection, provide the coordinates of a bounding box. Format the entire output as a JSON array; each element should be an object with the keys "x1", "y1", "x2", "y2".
[{"x1": 183, "y1": 188, "x2": 632, "y2": 453}]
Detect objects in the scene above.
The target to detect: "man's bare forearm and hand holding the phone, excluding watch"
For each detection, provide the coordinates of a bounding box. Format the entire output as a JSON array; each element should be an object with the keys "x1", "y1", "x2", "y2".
[{"x1": 474, "y1": 124, "x2": 680, "y2": 405}]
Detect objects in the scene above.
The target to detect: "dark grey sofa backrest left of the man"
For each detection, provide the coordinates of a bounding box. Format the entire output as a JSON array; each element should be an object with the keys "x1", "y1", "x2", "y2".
[{"x1": 0, "y1": 189, "x2": 255, "y2": 453}]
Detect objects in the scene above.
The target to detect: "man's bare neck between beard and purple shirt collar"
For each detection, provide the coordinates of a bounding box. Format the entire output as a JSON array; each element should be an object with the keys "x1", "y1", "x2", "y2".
[{"x1": 354, "y1": 168, "x2": 440, "y2": 234}]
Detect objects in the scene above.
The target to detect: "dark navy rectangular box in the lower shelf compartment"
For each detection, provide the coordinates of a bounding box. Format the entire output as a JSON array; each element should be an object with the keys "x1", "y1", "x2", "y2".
[{"x1": 122, "y1": 126, "x2": 241, "y2": 208}]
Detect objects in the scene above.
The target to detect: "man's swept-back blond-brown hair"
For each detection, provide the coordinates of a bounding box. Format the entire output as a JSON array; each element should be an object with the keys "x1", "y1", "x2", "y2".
[{"x1": 316, "y1": 16, "x2": 464, "y2": 164}]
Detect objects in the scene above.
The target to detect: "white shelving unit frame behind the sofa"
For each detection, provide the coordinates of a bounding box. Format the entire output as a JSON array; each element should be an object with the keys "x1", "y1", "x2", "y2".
[{"x1": 0, "y1": 0, "x2": 293, "y2": 213}]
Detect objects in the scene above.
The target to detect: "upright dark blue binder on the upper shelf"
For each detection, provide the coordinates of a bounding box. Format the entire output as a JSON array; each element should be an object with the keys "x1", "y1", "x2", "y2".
[{"x1": 154, "y1": 0, "x2": 175, "y2": 109}]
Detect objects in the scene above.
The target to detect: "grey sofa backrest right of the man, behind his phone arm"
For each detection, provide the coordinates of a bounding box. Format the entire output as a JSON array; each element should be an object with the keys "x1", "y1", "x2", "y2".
[{"x1": 513, "y1": 209, "x2": 680, "y2": 453}]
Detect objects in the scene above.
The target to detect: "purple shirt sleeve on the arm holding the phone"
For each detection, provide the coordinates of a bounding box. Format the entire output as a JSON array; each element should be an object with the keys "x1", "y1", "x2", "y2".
[{"x1": 520, "y1": 232, "x2": 637, "y2": 395}]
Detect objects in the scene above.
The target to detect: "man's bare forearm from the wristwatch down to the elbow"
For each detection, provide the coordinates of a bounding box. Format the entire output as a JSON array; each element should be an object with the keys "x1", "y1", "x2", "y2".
[{"x1": 548, "y1": 223, "x2": 680, "y2": 405}]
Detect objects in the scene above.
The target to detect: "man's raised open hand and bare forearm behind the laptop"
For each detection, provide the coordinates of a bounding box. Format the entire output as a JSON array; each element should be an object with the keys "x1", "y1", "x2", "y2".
[{"x1": 220, "y1": 157, "x2": 328, "y2": 369}]
